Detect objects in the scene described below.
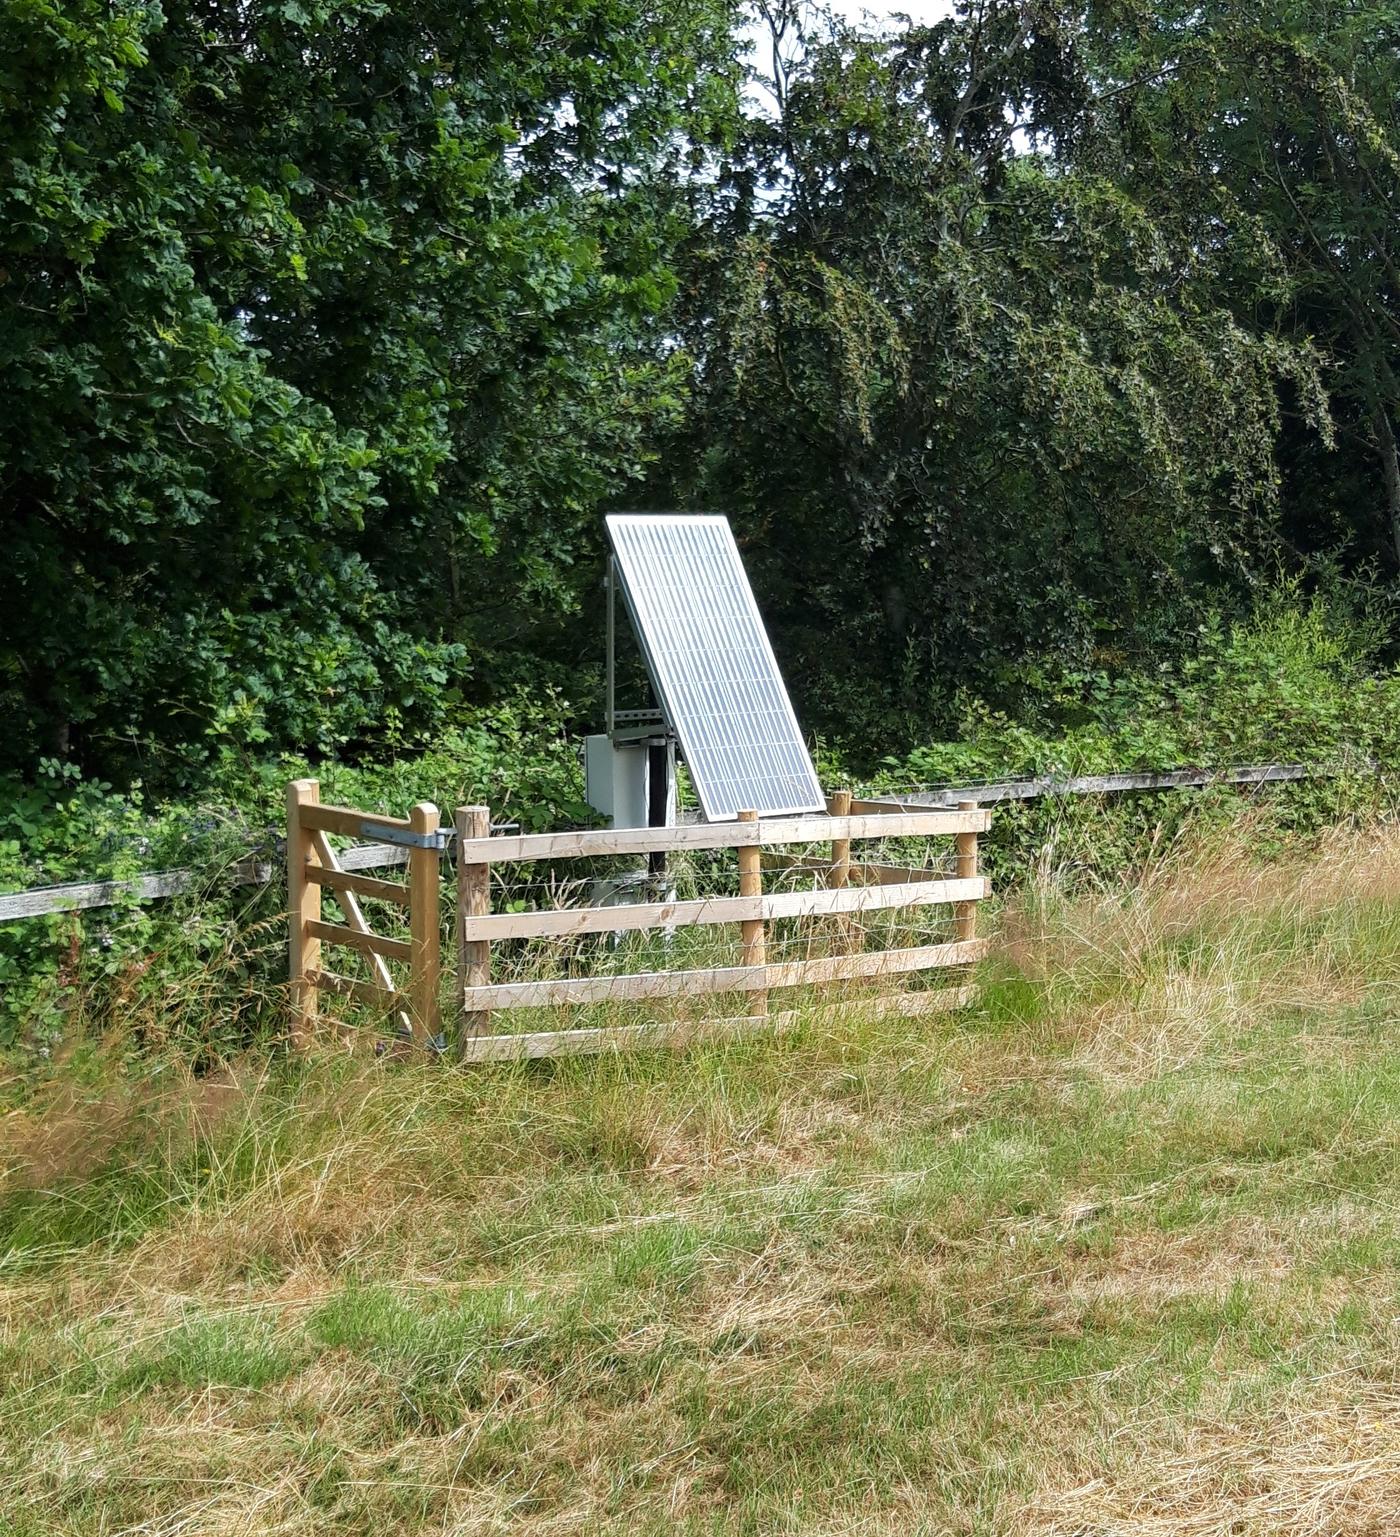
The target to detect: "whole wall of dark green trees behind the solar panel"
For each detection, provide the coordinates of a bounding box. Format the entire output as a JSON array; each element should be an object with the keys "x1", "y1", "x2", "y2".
[{"x1": 0, "y1": 0, "x2": 1400, "y2": 790}]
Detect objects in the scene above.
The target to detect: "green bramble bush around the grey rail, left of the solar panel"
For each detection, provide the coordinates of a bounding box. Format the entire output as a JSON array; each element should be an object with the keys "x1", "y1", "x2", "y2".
[{"x1": 0, "y1": 696, "x2": 589, "y2": 1056}]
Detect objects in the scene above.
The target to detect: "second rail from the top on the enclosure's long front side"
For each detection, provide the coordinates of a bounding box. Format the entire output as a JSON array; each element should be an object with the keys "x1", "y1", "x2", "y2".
[{"x1": 463, "y1": 879, "x2": 990, "y2": 939}]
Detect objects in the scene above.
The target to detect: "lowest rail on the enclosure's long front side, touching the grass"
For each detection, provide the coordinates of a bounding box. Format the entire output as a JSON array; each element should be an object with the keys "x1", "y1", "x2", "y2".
[{"x1": 463, "y1": 987, "x2": 977, "y2": 1062}]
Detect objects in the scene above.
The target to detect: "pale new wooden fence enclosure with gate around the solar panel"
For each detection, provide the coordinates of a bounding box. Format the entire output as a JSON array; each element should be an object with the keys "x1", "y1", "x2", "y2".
[{"x1": 287, "y1": 781, "x2": 991, "y2": 1062}]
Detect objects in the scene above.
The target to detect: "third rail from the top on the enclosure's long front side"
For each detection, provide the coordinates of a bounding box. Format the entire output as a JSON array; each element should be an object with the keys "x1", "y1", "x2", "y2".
[{"x1": 463, "y1": 939, "x2": 987, "y2": 1008}]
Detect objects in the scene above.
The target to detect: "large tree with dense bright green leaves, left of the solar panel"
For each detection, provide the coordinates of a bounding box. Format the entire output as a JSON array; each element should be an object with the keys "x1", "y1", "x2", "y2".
[{"x1": 0, "y1": 0, "x2": 735, "y2": 773}]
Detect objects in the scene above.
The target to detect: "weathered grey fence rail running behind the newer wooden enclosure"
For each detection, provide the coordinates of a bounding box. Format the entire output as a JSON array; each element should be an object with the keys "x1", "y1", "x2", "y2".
[{"x1": 0, "y1": 764, "x2": 1358, "y2": 924}]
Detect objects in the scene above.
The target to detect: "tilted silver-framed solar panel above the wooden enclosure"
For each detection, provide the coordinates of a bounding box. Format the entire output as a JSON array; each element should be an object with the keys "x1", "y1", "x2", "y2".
[{"x1": 607, "y1": 513, "x2": 827, "y2": 822}]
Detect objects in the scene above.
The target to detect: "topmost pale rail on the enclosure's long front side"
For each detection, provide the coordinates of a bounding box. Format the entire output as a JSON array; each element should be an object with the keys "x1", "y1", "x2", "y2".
[{"x1": 463, "y1": 810, "x2": 991, "y2": 864}]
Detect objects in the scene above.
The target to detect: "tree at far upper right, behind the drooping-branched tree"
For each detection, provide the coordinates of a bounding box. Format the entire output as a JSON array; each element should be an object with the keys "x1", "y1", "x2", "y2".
[{"x1": 1094, "y1": 0, "x2": 1400, "y2": 569}]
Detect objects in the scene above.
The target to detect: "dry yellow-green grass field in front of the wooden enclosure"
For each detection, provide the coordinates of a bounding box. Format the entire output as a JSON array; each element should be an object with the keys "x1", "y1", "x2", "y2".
[{"x1": 0, "y1": 833, "x2": 1400, "y2": 1537}]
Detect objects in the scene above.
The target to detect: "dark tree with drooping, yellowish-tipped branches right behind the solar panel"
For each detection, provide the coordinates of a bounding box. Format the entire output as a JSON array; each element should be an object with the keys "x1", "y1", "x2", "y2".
[{"x1": 672, "y1": 0, "x2": 1323, "y2": 744}]
